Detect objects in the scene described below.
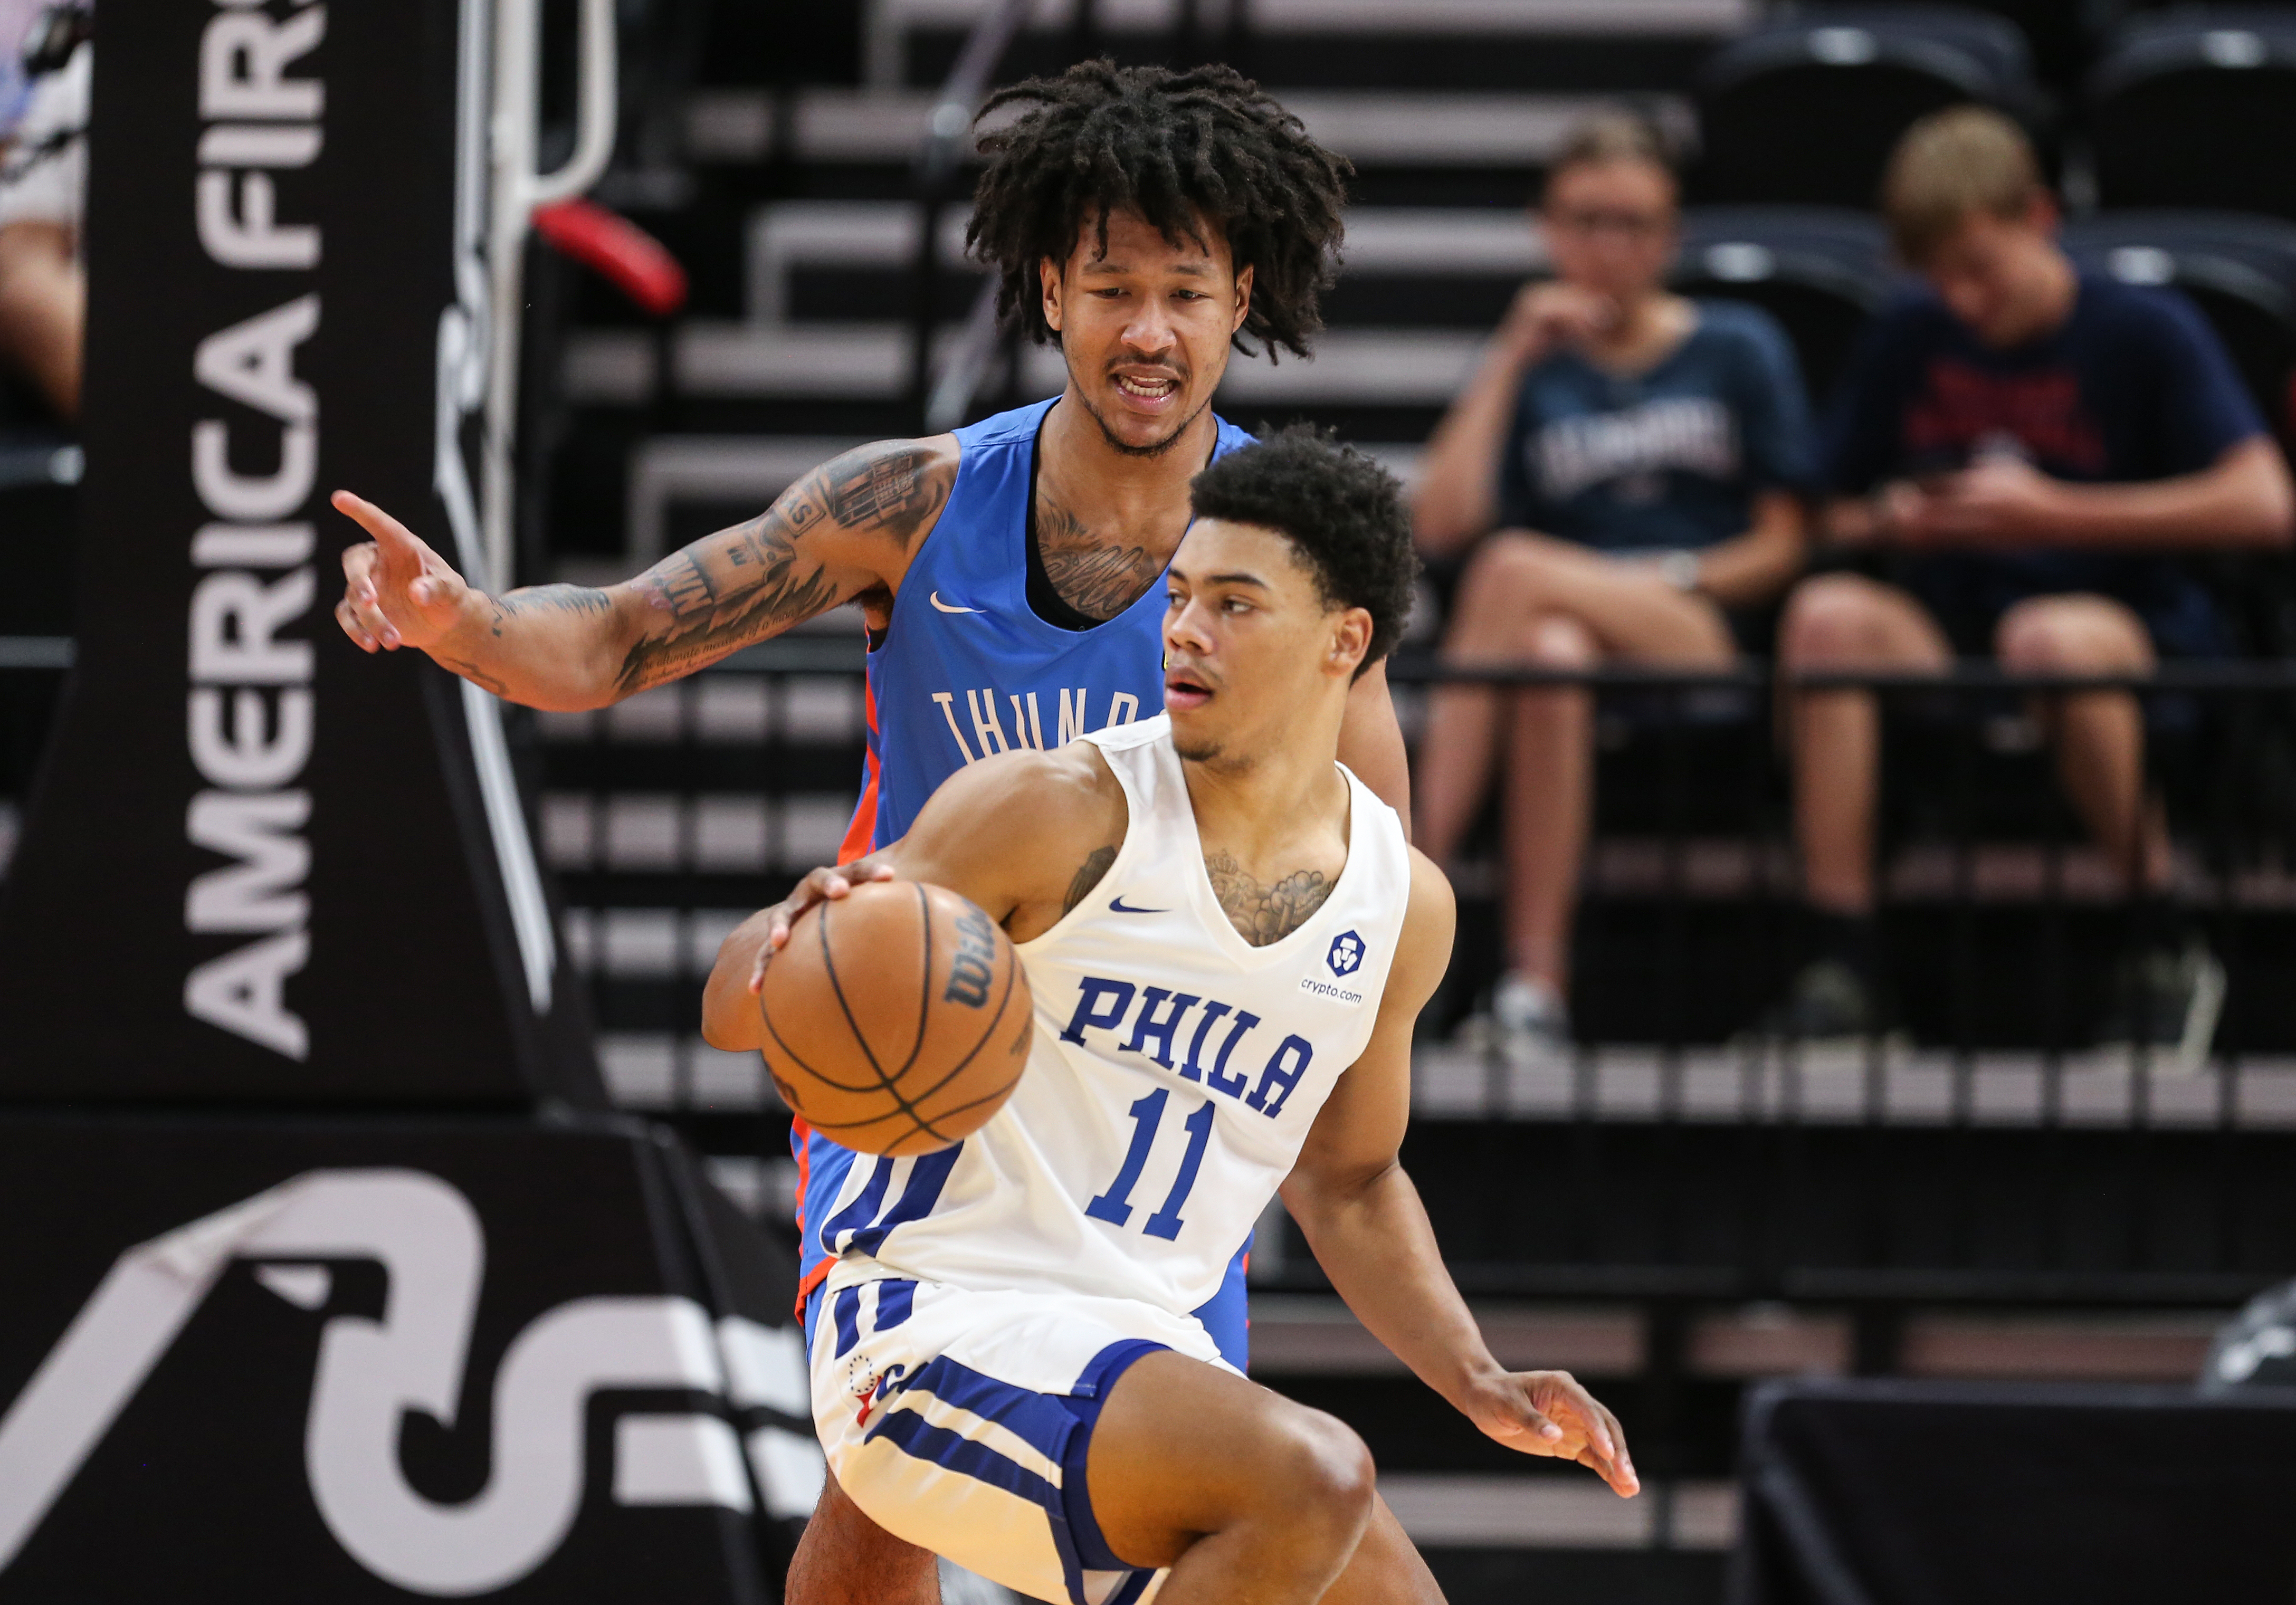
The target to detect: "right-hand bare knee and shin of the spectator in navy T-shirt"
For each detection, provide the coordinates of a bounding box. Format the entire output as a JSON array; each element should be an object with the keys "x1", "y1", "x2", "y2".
[{"x1": 1993, "y1": 595, "x2": 2167, "y2": 891}]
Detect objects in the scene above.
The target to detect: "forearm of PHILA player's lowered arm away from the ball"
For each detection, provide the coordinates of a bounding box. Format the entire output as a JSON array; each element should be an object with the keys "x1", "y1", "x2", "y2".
[{"x1": 1283, "y1": 1164, "x2": 1502, "y2": 1405}]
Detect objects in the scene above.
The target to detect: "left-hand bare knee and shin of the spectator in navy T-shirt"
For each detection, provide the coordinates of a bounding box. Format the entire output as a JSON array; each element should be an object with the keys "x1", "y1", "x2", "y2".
[{"x1": 1777, "y1": 574, "x2": 1954, "y2": 914}]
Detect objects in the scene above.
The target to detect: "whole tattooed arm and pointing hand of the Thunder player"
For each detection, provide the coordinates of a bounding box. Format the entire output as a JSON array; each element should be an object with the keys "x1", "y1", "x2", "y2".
[{"x1": 335, "y1": 436, "x2": 957, "y2": 710}]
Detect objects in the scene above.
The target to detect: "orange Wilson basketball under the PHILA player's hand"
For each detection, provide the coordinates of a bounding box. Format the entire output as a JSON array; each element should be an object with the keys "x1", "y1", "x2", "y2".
[{"x1": 758, "y1": 882, "x2": 1035, "y2": 1155}]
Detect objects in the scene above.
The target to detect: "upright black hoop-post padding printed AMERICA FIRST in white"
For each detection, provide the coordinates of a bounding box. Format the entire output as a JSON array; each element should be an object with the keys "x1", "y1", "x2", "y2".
[{"x1": 0, "y1": 0, "x2": 597, "y2": 1104}]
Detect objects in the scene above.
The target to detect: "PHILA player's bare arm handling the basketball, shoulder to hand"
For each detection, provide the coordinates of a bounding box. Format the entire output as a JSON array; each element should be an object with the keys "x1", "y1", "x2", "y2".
[{"x1": 702, "y1": 742, "x2": 1127, "y2": 1052}]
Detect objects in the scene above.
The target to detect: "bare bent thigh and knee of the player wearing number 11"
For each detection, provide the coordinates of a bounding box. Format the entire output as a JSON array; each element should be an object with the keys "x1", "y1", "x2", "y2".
[{"x1": 1086, "y1": 1352, "x2": 1373, "y2": 1566}]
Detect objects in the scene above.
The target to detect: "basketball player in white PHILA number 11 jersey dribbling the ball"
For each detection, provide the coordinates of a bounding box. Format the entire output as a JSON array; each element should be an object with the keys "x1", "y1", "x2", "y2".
[{"x1": 705, "y1": 432, "x2": 1637, "y2": 1605}]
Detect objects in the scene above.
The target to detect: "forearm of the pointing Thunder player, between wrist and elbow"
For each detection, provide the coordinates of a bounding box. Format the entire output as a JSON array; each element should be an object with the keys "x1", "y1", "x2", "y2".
[{"x1": 430, "y1": 586, "x2": 634, "y2": 712}]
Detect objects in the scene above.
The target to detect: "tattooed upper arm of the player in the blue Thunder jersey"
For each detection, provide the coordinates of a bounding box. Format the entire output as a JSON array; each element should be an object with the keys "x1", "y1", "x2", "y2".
[{"x1": 613, "y1": 441, "x2": 957, "y2": 696}]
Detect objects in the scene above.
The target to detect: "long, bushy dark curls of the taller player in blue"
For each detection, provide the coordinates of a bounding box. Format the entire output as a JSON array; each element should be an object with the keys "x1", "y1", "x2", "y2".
[{"x1": 964, "y1": 60, "x2": 1355, "y2": 360}]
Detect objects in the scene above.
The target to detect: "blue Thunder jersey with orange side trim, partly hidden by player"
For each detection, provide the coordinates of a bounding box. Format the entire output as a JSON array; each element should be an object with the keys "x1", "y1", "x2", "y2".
[{"x1": 790, "y1": 397, "x2": 1251, "y2": 1341}]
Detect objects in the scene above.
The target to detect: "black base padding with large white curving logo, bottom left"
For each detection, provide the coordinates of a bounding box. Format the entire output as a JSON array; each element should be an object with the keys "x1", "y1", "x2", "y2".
[{"x1": 0, "y1": 1118, "x2": 820, "y2": 1605}]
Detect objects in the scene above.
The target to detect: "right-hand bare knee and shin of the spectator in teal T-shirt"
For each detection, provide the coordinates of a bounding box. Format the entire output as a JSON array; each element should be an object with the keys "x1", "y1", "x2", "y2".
[{"x1": 1506, "y1": 613, "x2": 1600, "y2": 994}]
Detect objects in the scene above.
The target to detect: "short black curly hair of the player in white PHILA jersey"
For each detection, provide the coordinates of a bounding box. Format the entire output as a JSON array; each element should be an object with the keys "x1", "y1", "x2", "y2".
[{"x1": 1187, "y1": 425, "x2": 1419, "y2": 677}]
